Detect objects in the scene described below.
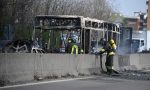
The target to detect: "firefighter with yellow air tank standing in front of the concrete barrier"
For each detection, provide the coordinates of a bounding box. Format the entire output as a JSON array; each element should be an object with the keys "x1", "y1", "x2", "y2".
[{"x1": 100, "y1": 38, "x2": 116, "y2": 75}]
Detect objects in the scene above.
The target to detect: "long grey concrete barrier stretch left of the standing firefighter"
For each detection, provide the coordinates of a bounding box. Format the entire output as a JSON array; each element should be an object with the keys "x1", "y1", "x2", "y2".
[{"x1": 0, "y1": 53, "x2": 100, "y2": 82}]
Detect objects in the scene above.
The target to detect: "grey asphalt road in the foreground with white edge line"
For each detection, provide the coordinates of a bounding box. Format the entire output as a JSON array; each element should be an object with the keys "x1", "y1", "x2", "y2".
[{"x1": 0, "y1": 76, "x2": 150, "y2": 90}]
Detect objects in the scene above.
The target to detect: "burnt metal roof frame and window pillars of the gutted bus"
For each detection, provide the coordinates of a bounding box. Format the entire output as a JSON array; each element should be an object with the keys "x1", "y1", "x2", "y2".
[{"x1": 32, "y1": 15, "x2": 120, "y2": 52}]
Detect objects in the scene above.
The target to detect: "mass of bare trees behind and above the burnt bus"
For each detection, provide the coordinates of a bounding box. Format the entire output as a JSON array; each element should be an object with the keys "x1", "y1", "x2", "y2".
[{"x1": 0, "y1": 0, "x2": 113, "y2": 38}]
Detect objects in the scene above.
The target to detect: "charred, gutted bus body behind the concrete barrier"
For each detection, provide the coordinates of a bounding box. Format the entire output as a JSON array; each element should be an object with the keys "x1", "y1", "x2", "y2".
[{"x1": 32, "y1": 15, "x2": 120, "y2": 53}]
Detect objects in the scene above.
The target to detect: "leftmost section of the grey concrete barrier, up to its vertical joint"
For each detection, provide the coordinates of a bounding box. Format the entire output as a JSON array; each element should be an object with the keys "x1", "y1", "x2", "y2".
[{"x1": 0, "y1": 53, "x2": 36, "y2": 82}]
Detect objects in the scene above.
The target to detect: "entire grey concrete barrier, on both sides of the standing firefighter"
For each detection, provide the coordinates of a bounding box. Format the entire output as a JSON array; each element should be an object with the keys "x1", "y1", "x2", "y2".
[{"x1": 0, "y1": 53, "x2": 150, "y2": 82}]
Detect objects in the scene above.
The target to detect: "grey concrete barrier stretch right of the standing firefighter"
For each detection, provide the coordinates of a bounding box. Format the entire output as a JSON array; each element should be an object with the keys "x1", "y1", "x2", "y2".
[{"x1": 118, "y1": 53, "x2": 150, "y2": 70}]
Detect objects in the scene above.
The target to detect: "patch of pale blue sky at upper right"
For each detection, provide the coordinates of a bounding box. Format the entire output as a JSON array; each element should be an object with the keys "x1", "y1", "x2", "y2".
[{"x1": 114, "y1": 0, "x2": 147, "y2": 17}]
